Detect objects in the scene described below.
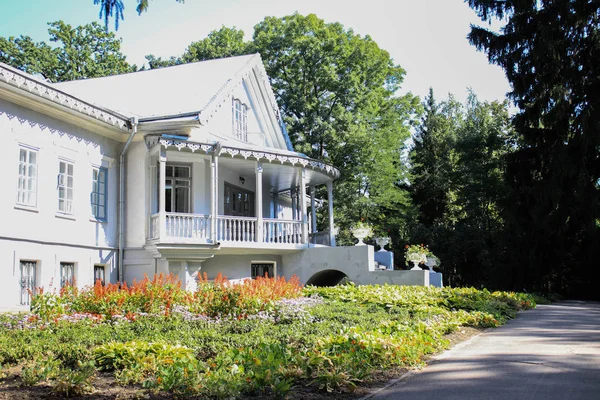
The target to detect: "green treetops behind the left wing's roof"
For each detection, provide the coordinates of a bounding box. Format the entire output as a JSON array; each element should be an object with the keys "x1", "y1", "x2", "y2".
[{"x1": 0, "y1": 21, "x2": 136, "y2": 82}]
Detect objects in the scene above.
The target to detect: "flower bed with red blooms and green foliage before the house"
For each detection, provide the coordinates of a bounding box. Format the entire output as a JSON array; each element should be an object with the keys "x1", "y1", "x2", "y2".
[{"x1": 0, "y1": 275, "x2": 535, "y2": 398}]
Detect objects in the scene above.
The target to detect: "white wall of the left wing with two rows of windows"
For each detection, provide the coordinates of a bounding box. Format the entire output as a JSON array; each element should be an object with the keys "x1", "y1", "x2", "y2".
[{"x1": 0, "y1": 100, "x2": 122, "y2": 307}]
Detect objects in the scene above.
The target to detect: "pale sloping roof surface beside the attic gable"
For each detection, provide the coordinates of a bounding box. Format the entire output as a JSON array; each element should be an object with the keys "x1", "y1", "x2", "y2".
[{"x1": 55, "y1": 54, "x2": 262, "y2": 119}]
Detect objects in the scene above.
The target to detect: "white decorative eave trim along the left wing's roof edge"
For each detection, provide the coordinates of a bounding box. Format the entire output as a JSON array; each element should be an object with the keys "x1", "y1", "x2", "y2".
[{"x1": 0, "y1": 64, "x2": 129, "y2": 131}]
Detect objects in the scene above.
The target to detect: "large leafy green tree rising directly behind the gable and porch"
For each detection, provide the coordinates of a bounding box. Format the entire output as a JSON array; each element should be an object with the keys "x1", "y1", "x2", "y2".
[{"x1": 253, "y1": 13, "x2": 419, "y2": 243}]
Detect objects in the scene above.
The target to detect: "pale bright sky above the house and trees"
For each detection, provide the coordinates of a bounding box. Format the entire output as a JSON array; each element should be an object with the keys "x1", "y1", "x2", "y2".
[{"x1": 0, "y1": 0, "x2": 510, "y2": 101}]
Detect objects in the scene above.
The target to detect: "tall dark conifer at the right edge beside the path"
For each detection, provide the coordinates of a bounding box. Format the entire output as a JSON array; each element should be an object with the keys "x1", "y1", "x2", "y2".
[{"x1": 469, "y1": 0, "x2": 600, "y2": 296}]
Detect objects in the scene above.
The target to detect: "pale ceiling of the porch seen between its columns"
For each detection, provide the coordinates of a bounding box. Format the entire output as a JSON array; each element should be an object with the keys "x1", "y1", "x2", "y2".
[{"x1": 219, "y1": 156, "x2": 333, "y2": 192}]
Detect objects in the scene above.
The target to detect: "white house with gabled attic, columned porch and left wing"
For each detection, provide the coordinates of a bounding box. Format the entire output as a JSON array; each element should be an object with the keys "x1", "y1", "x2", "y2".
[{"x1": 0, "y1": 54, "x2": 342, "y2": 307}]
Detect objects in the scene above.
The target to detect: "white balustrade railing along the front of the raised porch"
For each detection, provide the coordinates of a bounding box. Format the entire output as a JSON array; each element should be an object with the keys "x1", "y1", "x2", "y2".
[{"x1": 148, "y1": 213, "x2": 318, "y2": 245}]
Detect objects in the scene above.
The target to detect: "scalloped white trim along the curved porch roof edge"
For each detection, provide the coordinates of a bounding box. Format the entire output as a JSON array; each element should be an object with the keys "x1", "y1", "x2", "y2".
[{"x1": 145, "y1": 135, "x2": 340, "y2": 179}]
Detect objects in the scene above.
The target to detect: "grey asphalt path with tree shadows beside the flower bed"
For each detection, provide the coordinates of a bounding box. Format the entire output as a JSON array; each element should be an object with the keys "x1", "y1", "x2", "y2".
[{"x1": 366, "y1": 301, "x2": 600, "y2": 400}]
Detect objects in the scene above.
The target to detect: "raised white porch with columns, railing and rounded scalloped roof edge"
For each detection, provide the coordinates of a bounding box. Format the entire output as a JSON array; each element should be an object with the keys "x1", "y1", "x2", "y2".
[{"x1": 145, "y1": 139, "x2": 339, "y2": 260}]
